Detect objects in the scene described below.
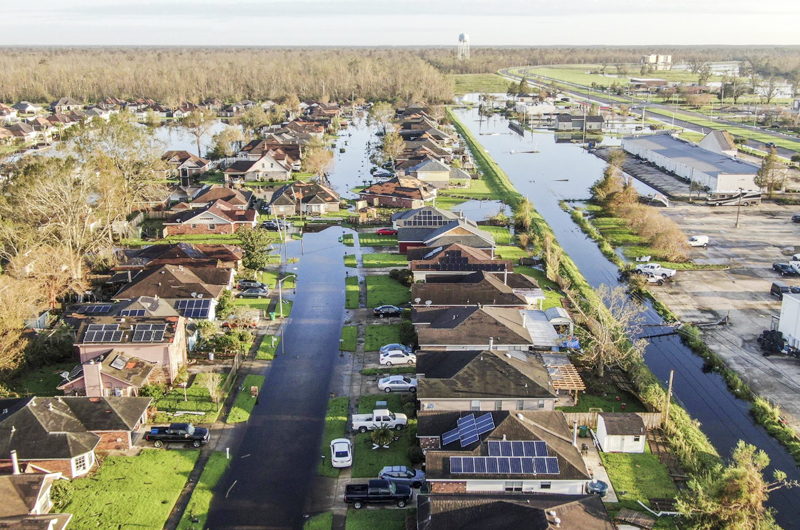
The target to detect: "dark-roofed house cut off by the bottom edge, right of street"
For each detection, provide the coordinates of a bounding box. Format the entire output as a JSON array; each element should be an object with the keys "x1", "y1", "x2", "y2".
[{"x1": 417, "y1": 492, "x2": 616, "y2": 530}]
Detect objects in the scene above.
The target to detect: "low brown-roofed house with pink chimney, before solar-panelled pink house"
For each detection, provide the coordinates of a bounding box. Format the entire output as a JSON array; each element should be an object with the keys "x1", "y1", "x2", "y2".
[{"x1": 57, "y1": 349, "x2": 156, "y2": 397}]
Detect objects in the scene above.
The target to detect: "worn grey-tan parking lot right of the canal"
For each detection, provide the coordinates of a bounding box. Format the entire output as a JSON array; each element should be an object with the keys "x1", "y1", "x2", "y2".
[{"x1": 652, "y1": 203, "x2": 800, "y2": 430}]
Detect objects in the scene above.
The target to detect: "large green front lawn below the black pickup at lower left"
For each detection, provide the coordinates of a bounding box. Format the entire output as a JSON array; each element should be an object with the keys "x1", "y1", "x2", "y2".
[{"x1": 64, "y1": 449, "x2": 200, "y2": 530}]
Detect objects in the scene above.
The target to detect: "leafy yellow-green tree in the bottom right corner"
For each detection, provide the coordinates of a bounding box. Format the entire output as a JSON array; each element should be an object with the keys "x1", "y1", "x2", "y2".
[{"x1": 676, "y1": 440, "x2": 797, "y2": 530}]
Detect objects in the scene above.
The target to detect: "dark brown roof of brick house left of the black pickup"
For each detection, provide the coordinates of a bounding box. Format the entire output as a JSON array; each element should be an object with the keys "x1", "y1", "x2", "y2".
[{"x1": 0, "y1": 397, "x2": 151, "y2": 460}]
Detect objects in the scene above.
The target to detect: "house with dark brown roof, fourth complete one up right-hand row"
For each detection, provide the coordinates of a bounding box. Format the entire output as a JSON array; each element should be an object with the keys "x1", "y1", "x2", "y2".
[{"x1": 411, "y1": 270, "x2": 545, "y2": 309}]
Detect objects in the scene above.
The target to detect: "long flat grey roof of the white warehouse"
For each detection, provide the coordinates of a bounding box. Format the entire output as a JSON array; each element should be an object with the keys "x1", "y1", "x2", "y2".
[{"x1": 622, "y1": 134, "x2": 758, "y2": 177}]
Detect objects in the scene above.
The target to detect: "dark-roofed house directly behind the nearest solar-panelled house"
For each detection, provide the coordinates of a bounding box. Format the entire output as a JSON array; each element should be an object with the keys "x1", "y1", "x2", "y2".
[{"x1": 417, "y1": 350, "x2": 558, "y2": 411}]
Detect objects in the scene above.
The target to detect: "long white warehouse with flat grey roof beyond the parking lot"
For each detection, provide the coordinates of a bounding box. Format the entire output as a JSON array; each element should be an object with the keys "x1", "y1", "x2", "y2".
[{"x1": 622, "y1": 134, "x2": 759, "y2": 193}]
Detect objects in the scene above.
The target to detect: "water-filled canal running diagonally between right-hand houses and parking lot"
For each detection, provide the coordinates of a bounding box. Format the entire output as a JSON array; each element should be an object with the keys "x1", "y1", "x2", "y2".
[{"x1": 456, "y1": 105, "x2": 800, "y2": 529}]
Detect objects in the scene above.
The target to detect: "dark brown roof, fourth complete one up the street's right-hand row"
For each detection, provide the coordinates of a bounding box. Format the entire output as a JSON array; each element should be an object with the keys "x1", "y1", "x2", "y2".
[{"x1": 411, "y1": 271, "x2": 528, "y2": 307}]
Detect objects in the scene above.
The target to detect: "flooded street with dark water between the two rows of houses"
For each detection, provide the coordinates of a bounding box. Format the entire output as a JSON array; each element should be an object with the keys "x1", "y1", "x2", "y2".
[{"x1": 207, "y1": 228, "x2": 345, "y2": 530}]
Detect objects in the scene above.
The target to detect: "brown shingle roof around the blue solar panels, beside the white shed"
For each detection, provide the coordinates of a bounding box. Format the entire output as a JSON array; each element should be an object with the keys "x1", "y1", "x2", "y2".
[{"x1": 417, "y1": 410, "x2": 591, "y2": 480}]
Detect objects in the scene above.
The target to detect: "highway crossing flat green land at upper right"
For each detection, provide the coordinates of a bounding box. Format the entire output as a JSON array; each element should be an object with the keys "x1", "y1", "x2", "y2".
[{"x1": 500, "y1": 69, "x2": 800, "y2": 158}]
